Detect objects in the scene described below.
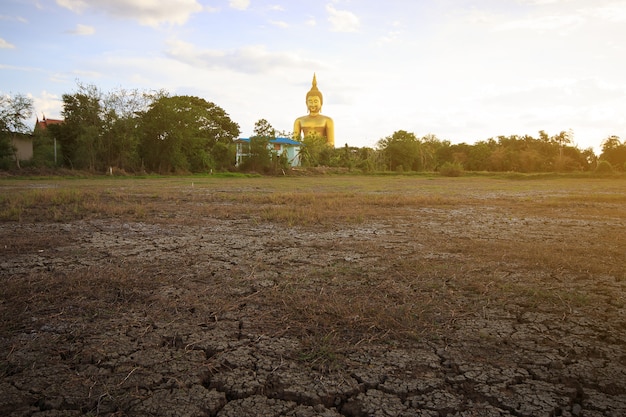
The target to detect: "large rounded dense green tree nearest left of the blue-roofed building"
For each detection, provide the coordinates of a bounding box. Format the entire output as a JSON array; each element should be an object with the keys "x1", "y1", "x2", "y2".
[{"x1": 140, "y1": 96, "x2": 239, "y2": 173}]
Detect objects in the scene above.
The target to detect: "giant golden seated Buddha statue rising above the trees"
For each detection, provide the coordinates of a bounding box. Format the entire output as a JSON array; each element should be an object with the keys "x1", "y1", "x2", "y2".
[{"x1": 293, "y1": 74, "x2": 335, "y2": 147}]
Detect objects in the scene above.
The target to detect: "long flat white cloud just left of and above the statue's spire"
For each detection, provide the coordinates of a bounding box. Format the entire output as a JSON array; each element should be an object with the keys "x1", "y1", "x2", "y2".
[{"x1": 166, "y1": 40, "x2": 321, "y2": 74}]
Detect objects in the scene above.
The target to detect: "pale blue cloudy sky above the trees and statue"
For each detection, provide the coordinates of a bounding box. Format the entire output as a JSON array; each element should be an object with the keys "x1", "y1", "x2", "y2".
[{"x1": 0, "y1": 0, "x2": 626, "y2": 154}]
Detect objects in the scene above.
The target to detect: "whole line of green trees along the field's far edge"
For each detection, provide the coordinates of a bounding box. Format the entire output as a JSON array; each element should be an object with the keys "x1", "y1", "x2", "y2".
[{"x1": 0, "y1": 84, "x2": 626, "y2": 174}]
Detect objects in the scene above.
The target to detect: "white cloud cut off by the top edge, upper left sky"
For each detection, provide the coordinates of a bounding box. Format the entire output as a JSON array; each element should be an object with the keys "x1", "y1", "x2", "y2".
[{"x1": 56, "y1": 0, "x2": 203, "y2": 27}]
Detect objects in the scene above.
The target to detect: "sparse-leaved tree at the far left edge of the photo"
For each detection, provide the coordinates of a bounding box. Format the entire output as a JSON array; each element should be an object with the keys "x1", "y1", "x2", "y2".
[{"x1": 0, "y1": 94, "x2": 33, "y2": 168}]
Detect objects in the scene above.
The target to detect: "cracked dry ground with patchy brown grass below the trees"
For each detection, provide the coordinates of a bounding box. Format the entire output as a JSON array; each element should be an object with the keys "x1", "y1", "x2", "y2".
[{"x1": 0, "y1": 177, "x2": 626, "y2": 417}]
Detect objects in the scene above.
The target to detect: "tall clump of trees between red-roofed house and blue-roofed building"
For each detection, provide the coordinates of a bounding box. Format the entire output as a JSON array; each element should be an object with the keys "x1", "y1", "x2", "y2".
[{"x1": 48, "y1": 84, "x2": 239, "y2": 173}]
